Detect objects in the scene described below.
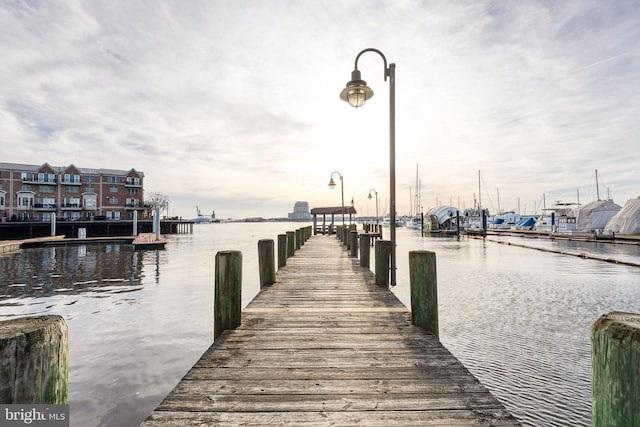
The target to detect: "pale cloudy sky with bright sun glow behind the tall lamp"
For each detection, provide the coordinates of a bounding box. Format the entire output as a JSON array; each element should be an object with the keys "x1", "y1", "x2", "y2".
[{"x1": 0, "y1": 0, "x2": 640, "y2": 218}]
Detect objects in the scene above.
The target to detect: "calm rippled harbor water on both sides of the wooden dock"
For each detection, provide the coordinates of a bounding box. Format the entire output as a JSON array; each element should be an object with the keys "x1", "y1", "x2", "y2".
[{"x1": 0, "y1": 223, "x2": 640, "y2": 427}]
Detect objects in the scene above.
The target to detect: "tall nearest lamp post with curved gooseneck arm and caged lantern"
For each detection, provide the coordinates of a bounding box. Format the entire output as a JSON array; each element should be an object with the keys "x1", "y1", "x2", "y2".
[{"x1": 340, "y1": 48, "x2": 396, "y2": 286}]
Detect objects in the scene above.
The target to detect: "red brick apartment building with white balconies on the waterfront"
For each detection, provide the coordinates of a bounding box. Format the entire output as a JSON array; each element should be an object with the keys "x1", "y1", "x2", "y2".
[{"x1": 0, "y1": 162, "x2": 146, "y2": 221}]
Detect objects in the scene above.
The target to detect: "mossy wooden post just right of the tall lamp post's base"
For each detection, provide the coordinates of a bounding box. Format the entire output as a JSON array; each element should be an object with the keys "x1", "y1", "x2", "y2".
[{"x1": 409, "y1": 251, "x2": 439, "y2": 338}]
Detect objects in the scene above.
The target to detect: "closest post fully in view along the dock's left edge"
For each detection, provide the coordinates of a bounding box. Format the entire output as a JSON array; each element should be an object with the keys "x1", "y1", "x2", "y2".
[{"x1": 213, "y1": 251, "x2": 242, "y2": 341}]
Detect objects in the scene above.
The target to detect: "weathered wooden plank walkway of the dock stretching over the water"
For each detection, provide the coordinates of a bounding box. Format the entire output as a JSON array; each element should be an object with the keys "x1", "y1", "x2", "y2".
[{"x1": 141, "y1": 236, "x2": 519, "y2": 427}]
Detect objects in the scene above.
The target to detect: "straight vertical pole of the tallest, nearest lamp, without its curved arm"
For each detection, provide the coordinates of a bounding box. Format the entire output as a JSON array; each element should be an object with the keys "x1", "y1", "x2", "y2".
[{"x1": 389, "y1": 64, "x2": 396, "y2": 286}]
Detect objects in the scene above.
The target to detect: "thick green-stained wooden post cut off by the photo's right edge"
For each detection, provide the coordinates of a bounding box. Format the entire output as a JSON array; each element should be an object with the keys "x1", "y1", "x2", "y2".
[{"x1": 591, "y1": 312, "x2": 640, "y2": 427}]
